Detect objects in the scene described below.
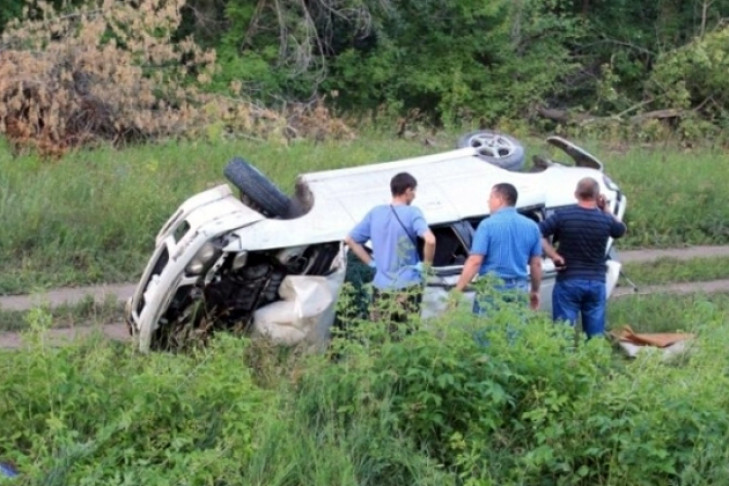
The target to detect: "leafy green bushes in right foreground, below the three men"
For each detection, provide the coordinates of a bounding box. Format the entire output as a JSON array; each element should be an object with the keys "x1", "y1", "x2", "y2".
[{"x1": 298, "y1": 290, "x2": 729, "y2": 485}]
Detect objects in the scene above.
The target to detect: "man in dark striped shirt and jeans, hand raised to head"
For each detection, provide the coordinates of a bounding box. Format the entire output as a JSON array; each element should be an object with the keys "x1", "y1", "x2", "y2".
[{"x1": 539, "y1": 177, "x2": 626, "y2": 338}]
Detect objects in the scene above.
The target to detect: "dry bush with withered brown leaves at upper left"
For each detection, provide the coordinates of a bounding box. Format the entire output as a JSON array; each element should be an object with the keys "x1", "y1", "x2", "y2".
[{"x1": 0, "y1": 0, "x2": 351, "y2": 155}]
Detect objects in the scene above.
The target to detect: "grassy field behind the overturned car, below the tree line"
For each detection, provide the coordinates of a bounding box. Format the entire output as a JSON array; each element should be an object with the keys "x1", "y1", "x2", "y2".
[{"x1": 0, "y1": 134, "x2": 729, "y2": 294}]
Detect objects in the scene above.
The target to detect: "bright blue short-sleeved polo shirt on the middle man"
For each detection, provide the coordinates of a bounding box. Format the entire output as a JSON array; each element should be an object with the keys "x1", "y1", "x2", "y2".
[{"x1": 471, "y1": 207, "x2": 542, "y2": 279}]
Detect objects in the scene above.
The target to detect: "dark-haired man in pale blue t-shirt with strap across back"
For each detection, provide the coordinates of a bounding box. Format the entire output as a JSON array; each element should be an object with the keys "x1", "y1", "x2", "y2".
[{"x1": 344, "y1": 172, "x2": 435, "y2": 321}]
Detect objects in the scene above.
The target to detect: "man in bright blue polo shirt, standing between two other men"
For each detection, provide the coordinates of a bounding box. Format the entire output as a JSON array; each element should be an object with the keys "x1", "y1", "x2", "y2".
[{"x1": 456, "y1": 183, "x2": 542, "y2": 314}]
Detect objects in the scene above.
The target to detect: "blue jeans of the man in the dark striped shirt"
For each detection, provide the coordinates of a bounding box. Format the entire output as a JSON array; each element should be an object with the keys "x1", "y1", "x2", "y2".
[{"x1": 552, "y1": 279, "x2": 605, "y2": 339}]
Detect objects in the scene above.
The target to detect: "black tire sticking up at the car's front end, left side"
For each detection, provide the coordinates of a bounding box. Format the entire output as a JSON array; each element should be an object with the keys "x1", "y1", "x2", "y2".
[{"x1": 223, "y1": 157, "x2": 291, "y2": 218}]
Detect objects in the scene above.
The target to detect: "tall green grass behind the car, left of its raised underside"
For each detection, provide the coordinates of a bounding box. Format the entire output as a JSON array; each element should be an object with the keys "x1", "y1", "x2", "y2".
[{"x1": 0, "y1": 137, "x2": 436, "y2": 294}]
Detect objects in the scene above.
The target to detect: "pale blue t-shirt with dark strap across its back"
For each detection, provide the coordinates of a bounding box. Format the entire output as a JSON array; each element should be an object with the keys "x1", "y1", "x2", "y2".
[{"x1": 349, "y1": 204, "x2": 429, "y2": 290}]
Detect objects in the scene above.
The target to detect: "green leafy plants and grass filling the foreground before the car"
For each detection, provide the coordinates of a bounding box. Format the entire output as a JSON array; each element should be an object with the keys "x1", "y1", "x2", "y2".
[{"x1": 0, "y1": 299, "x2": 729, "y2": 486}]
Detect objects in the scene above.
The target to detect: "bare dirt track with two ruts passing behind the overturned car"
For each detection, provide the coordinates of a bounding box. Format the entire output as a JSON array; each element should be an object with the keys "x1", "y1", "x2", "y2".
[{"x1": 0, "y1": 246, "x2": 729, "y2": 348}]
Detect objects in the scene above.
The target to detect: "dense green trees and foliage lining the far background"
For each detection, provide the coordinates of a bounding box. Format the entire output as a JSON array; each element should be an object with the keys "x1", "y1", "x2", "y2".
[{"x1": 0, "y1": 0, "x2": 729, "y2": 148}]
